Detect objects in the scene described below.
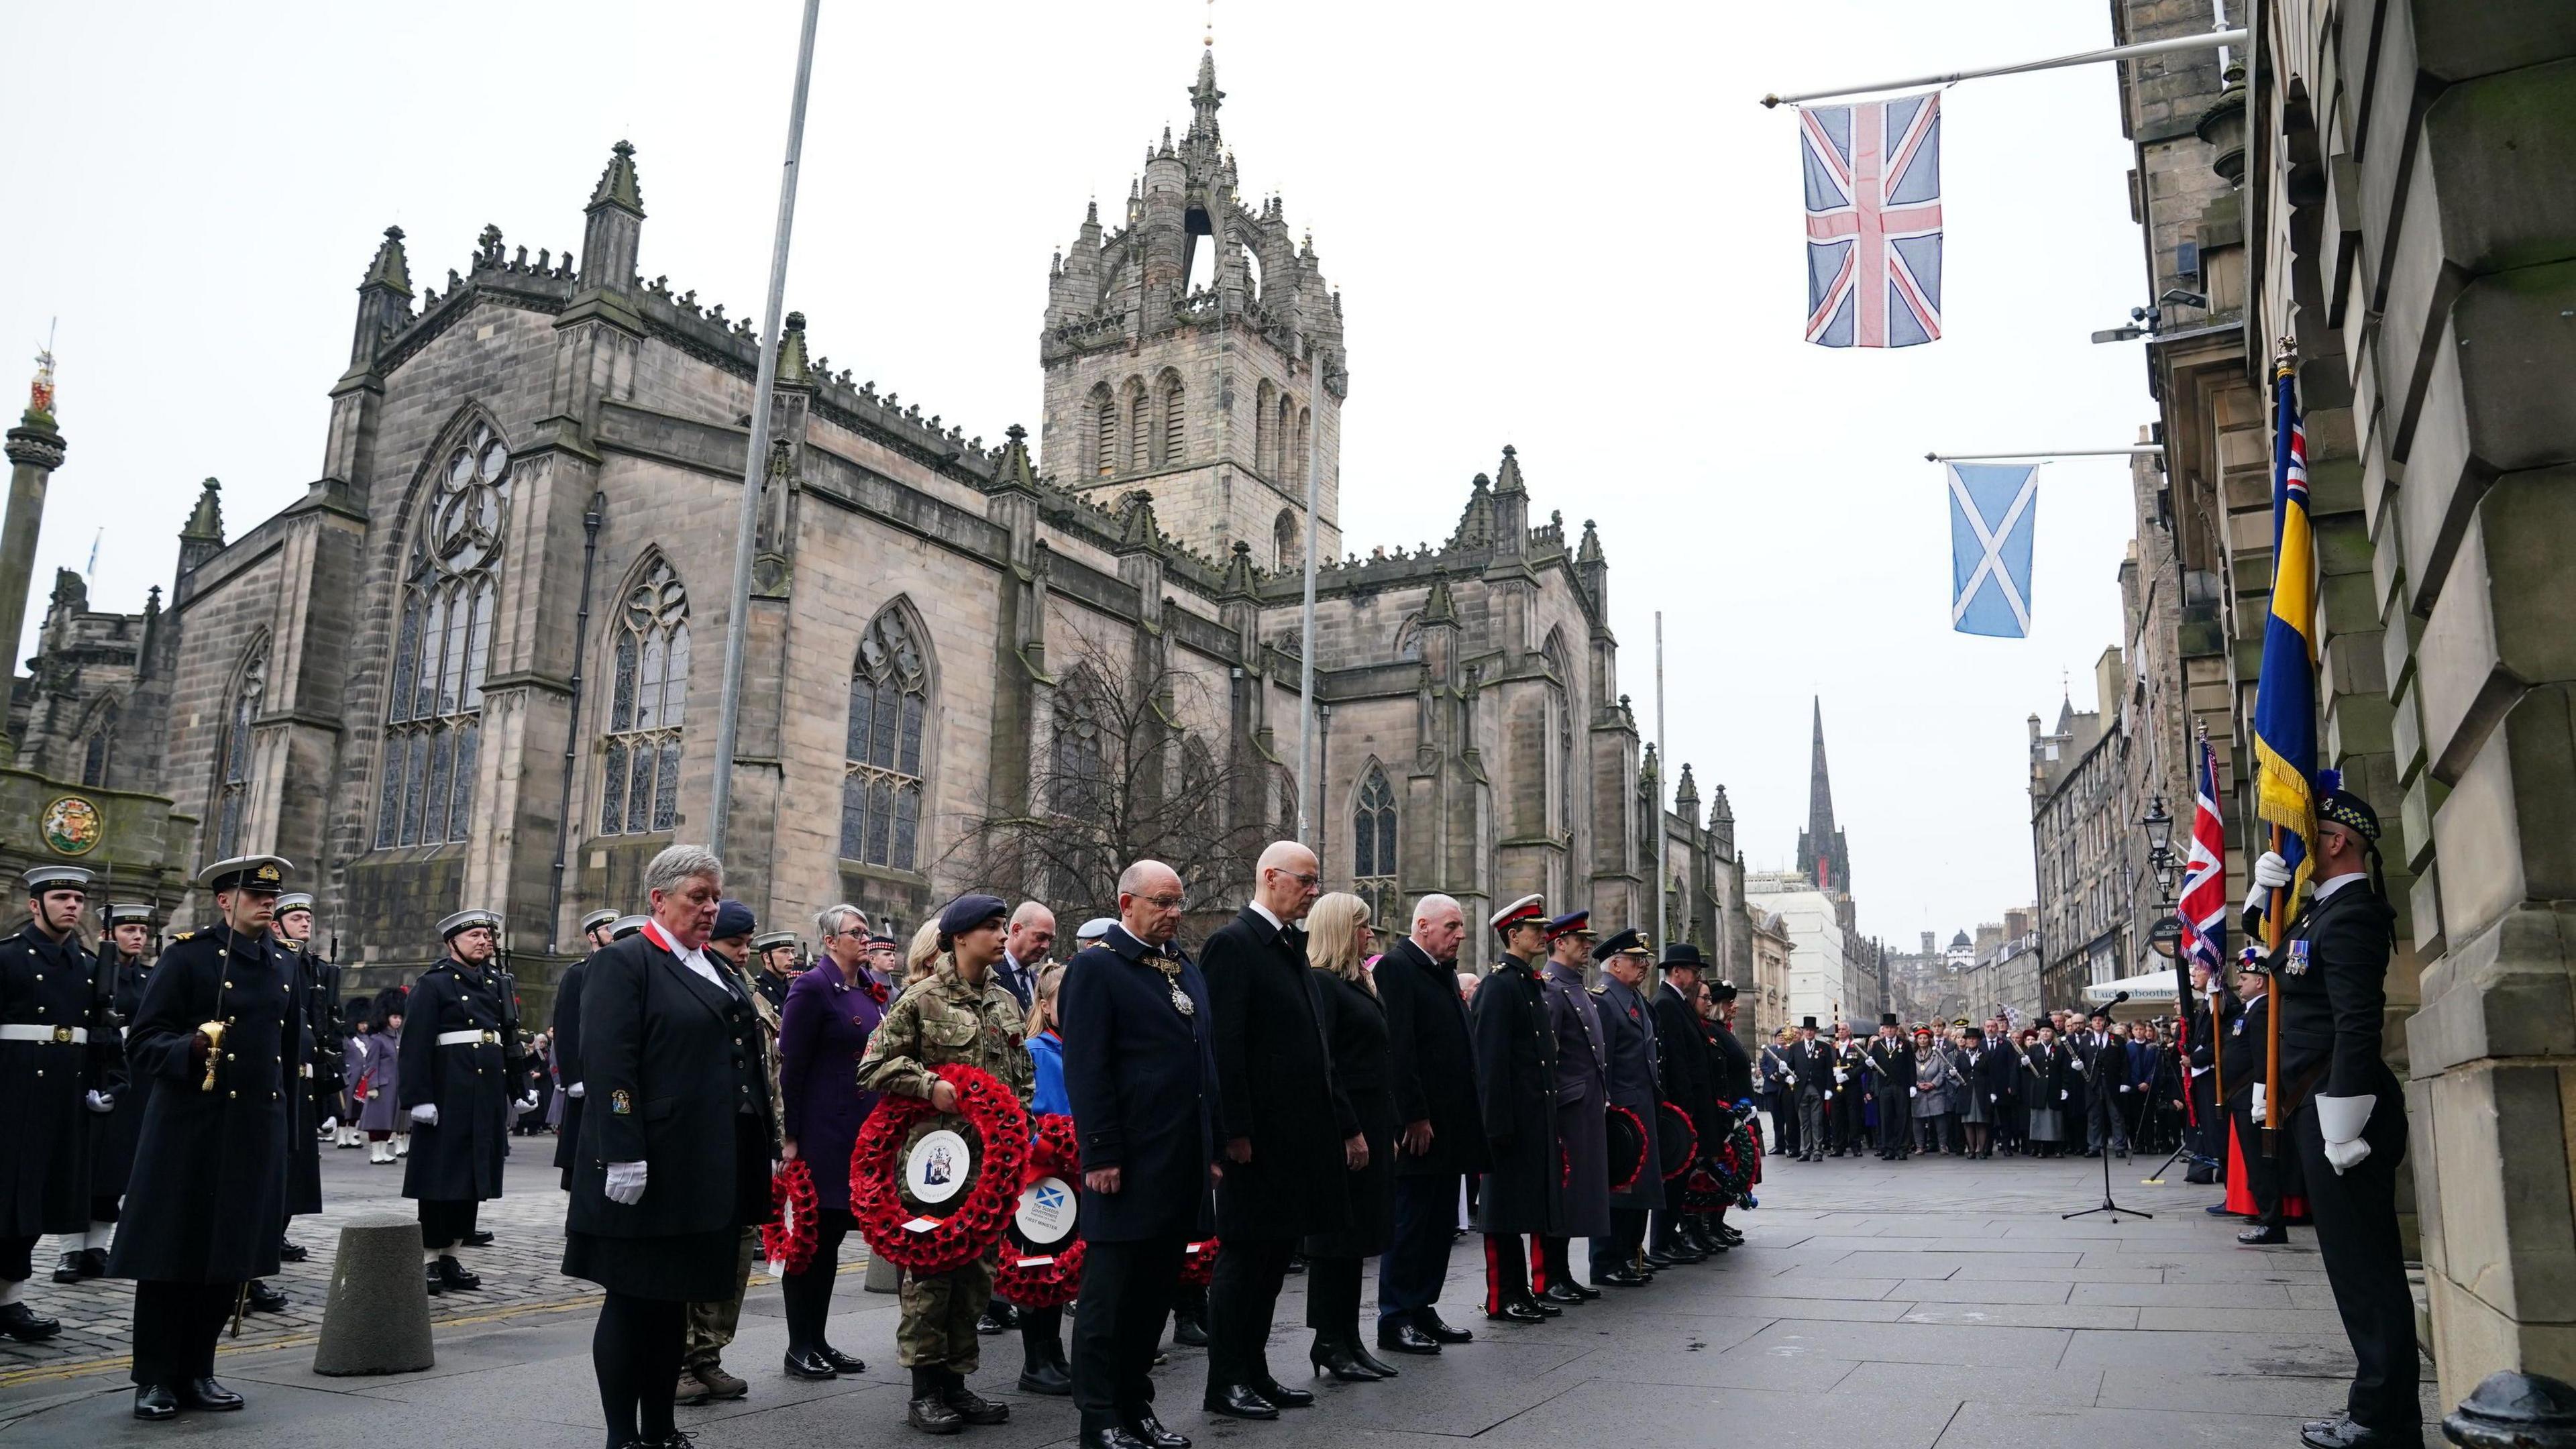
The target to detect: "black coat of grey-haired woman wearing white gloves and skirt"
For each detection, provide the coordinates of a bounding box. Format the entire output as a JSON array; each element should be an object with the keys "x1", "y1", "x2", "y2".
[{"x1": 561, "y1": 930, "x2": 778, "y2": 1238}]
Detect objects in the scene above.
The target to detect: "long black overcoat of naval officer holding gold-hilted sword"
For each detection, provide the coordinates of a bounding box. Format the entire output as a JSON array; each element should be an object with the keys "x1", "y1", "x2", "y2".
[{"x1": 108, "y1": 926, "x2": 304, "y2": 1284}]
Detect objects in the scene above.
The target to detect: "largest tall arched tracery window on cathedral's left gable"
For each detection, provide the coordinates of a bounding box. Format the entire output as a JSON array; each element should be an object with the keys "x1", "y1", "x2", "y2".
[{"x1": 376, "y1": 423, "x2": 510, "y2": 848}]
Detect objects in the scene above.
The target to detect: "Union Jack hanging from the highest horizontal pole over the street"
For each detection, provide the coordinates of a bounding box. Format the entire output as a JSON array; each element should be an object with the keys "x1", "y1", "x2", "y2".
[{"x1": 1798, "y1": 93, "x2": 1940, "y2": 348}]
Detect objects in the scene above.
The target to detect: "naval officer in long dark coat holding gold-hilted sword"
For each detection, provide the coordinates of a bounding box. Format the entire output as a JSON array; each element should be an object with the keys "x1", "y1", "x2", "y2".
[{"x1": 108, "y1": 856, "x2": 304, "y2": 1421}]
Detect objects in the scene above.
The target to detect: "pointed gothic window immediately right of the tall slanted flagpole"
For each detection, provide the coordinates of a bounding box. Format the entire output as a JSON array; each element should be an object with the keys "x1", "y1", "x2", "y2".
[{"x1": 840, "y1": 598, "x2": 930, "y2": 871}]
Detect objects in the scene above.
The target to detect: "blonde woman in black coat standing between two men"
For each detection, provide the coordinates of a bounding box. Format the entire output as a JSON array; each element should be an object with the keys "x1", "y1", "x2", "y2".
[{"x1": 1306, "y1": 892, "x2": 1396, "y2": 1382}]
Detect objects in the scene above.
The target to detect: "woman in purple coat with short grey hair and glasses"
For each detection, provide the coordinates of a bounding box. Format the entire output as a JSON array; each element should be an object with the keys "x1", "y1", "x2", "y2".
[{"x1": 778, "y1": 905, "x2": 892, "y2": 1379}]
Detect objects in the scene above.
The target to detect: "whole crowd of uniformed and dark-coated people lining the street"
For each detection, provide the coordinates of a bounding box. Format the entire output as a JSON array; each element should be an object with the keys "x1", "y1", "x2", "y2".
[{"x1": 0, "y1": 778, "x2": 2414, "y2": 1449}]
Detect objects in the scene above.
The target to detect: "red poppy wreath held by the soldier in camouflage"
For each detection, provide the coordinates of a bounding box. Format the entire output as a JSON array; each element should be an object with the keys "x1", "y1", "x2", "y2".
[{"x1": 850, "y1": 1065, "x2": 1028, "y2": 1279}]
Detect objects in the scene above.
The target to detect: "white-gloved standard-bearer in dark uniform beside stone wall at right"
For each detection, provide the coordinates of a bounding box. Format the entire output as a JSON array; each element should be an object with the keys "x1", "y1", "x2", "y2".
[{"x1": 2246, "y1": 789, "x2": 2424, "y2": 1449}]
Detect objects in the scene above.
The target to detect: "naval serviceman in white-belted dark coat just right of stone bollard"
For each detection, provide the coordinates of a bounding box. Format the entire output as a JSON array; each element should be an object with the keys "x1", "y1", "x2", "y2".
[{"x1": 396, "y1": 910, "x2": 536, "y2": 1294}]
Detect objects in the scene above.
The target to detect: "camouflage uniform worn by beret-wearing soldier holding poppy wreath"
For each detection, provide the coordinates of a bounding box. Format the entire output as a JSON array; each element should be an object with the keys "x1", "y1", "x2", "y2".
[{"x1": 858, "y1": 957, "x2": 1036, "y2": 1375}]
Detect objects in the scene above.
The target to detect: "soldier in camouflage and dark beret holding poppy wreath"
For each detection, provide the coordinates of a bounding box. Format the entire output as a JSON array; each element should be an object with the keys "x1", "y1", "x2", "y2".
[{"x1": 858, "y1": 895, "x2": 1036, "y2": 1434}]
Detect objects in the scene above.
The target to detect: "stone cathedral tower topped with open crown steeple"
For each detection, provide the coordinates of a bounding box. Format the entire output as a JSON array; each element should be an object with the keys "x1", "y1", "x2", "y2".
[{"x1": 1038, "y1": 46, "x2": 1350, "y2": 570}]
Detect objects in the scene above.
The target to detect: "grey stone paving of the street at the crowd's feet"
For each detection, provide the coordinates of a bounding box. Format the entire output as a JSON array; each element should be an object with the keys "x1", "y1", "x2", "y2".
[{"x1": 0, "y1": 1144, "x2": 2434, "y2": 1449}]
